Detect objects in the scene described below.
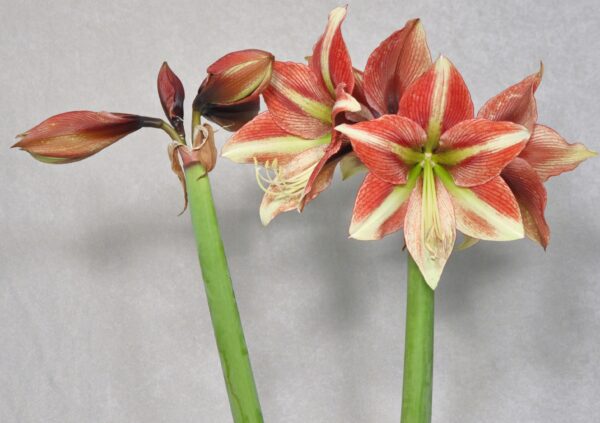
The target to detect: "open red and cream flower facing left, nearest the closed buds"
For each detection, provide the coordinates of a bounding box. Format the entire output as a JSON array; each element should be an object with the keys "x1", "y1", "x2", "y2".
[{"x1": 222, "y1": 7, "x2": 360, "y2": 225}]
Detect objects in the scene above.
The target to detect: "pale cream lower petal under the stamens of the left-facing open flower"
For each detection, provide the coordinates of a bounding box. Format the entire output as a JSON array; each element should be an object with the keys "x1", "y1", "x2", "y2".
[{"x1": 260, "y1": 146, "x2": 326, "y2": 226}]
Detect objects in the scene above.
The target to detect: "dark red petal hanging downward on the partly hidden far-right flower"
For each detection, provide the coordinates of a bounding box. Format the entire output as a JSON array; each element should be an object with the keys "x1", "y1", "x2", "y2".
[{"x1": 501, "y1": 157, "x2": 550, "y2": 249}]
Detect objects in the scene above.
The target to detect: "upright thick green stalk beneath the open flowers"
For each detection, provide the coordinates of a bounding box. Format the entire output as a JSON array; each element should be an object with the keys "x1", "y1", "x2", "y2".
[{"x1": 401, "y1": 254, "x2": 434, "y2": 423}]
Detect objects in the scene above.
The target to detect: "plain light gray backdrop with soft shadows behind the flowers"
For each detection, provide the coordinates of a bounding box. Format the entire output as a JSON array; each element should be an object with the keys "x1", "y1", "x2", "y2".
[{"x1": 0, "y1": 0, "x2": 600, "y2": 423}]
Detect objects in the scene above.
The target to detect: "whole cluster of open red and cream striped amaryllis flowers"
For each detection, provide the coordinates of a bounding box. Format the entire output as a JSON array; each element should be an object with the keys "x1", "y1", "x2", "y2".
[{"x1": 222, "y1": 7, "x2": 595, "y2": 288}]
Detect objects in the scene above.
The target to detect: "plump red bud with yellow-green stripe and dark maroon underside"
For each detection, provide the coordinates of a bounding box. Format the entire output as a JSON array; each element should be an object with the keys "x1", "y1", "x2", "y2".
[{"x1": 193, "y1": 50, "x2": 274, "y2": 131}]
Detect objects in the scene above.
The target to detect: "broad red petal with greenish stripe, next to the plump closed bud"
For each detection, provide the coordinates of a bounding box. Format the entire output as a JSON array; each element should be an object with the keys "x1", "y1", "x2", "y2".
[{"x1": 263, "y1": 61, "x2": 334, "y2": 139}]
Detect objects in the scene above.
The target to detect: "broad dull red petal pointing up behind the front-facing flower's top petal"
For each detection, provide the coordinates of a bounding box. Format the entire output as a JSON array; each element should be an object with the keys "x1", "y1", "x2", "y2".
[{"x1": 364, "y1": 19, "x2": 431, "y2": 115}]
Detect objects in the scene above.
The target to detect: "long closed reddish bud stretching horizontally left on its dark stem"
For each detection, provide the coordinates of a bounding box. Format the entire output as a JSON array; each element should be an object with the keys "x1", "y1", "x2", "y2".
[{"x1": 13, "y1": 111, "x2": 162, "y2": 164}]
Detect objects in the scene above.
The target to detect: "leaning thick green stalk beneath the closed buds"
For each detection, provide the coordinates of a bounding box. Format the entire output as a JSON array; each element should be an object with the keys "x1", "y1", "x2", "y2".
[{"x1": 185, "y1": 164, "x2": 263, "y2": 423}]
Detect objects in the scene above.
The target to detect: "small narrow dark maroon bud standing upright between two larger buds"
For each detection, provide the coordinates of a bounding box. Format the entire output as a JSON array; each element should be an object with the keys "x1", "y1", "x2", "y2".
[{"x1": 158, "y1": 62, "x2": 185, "y2": 138}]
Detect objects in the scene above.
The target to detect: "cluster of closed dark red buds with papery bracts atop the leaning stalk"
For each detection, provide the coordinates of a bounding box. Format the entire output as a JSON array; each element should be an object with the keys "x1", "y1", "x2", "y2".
[{"x1": 13, "y1": 50, "x2": 274, "y2": 210}]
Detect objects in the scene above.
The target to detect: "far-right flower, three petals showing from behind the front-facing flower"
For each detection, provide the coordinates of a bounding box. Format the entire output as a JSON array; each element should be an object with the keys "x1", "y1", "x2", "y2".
[{"x1": 478, "y1": 68, "x2": 596, "y2": 248}]
